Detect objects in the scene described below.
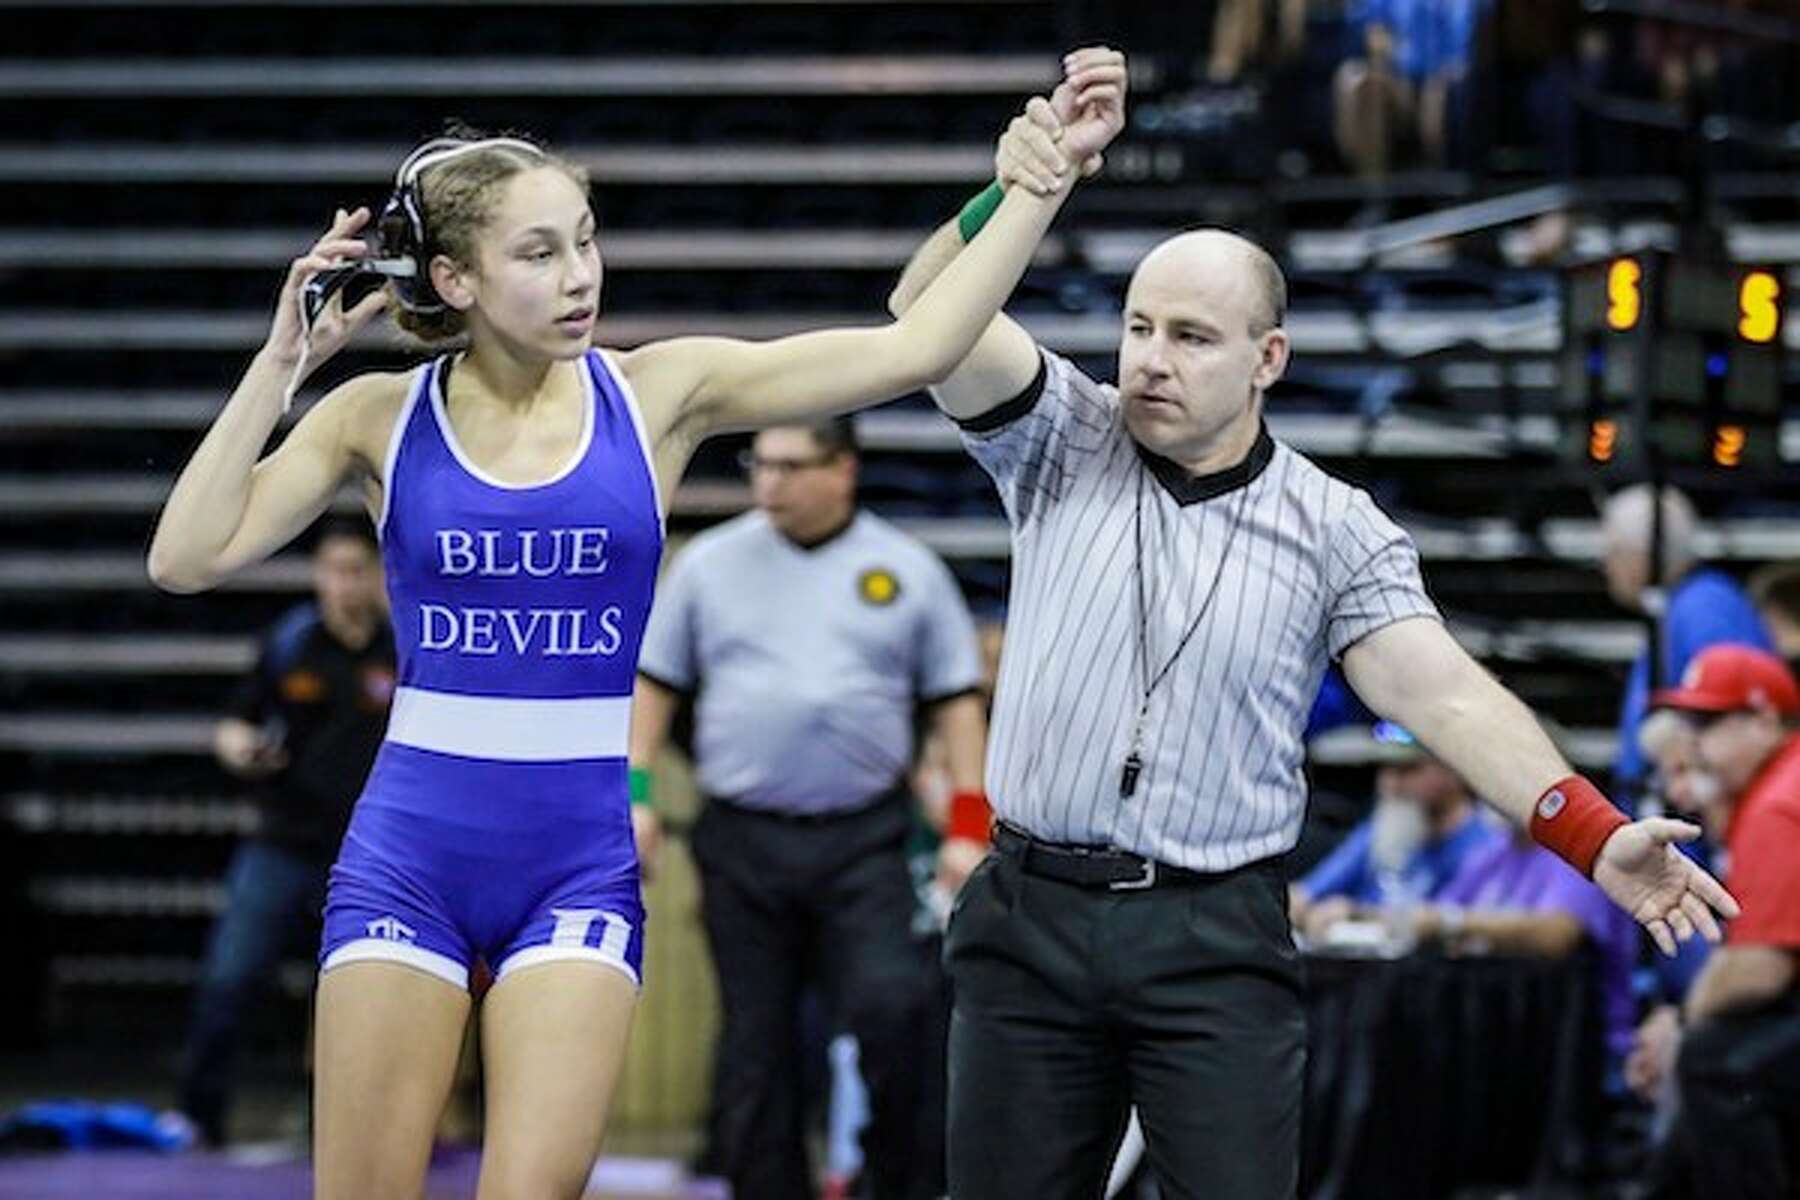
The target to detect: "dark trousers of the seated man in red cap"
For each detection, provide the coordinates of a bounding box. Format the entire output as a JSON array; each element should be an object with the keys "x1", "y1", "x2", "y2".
[{"x1": 1652, "y1": 997, "x2": 1800, "y2": 1200}]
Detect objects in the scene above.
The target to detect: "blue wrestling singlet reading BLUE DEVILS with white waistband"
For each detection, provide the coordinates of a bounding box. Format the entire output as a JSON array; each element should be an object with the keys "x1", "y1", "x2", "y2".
[{"x1": 320, "y1": 351, "x2": 662, "y2": 986}]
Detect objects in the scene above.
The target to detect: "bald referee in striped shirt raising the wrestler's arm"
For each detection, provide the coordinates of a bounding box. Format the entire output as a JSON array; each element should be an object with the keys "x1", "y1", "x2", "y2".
[{"x1": 891, "y1": 49, "x2": 1735, "y2": 1200}]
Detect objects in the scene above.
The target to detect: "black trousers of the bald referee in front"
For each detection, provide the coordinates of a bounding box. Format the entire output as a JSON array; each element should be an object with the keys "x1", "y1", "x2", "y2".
[{"x1": 945, "y1": 851, "x2": 1307, "y2": 1200}]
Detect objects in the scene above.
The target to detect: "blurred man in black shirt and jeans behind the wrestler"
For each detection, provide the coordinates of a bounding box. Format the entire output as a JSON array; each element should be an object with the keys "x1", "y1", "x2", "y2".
[{"x1": 180, "y1": 520, "x2": 394, "y2": 1146}]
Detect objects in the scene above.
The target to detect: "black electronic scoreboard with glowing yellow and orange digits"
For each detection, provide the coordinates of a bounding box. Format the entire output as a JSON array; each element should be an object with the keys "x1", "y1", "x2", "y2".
[{"x1": 1562, "y1": 250, "x2": 1787, "y2": 471}]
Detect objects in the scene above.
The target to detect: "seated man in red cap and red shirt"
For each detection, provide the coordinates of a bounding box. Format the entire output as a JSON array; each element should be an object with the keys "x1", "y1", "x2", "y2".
[{"x1": 1629, "y1": 646, "x2": 1800, "y2": 1200}]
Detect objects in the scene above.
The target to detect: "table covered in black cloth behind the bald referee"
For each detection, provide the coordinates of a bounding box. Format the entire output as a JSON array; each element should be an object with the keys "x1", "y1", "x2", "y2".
[{"x1": 1300, "y1": 954, "x2": 1606, "y2": 1200}]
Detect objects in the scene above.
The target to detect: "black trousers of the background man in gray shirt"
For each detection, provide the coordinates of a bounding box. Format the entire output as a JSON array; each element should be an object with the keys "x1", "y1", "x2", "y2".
[{"x1": 693, "y1": 793, "x2": 943, "y2": 1200}]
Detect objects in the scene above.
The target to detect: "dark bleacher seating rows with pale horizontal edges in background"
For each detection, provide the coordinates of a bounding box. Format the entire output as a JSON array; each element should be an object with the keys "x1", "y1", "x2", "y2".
[{"x1": 0, "y1": 0, "x2": 1800, "y2": 1072}]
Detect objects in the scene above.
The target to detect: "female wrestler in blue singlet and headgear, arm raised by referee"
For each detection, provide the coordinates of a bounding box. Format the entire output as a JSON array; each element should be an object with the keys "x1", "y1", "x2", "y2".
[{"x1": 149, "y1": 56, "x2": 1123, "y2": 1198}]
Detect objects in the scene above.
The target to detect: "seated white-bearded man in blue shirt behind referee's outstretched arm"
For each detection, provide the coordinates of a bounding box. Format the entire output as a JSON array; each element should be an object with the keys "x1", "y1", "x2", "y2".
[{"x1": 1291, "y1": 721, "x2": 1501, "y2": 939}]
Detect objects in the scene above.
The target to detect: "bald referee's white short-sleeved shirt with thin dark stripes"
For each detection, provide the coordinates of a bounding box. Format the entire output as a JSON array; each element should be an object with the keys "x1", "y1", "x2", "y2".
[{"x1": 963, "y1": 353, "x2": 1438, "y2": 871}]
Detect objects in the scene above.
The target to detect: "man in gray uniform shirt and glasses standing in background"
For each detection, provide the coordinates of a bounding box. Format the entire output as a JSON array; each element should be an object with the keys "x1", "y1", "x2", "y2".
[{"x1": 632, "y1": 417, "x2": 986, "y2": 1200}]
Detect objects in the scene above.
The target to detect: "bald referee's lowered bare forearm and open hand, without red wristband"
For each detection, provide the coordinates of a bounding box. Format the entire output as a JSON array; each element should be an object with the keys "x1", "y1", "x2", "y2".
[{"x1": 1345, "y1": 617, "x2": 1737, "y2": 954}]
